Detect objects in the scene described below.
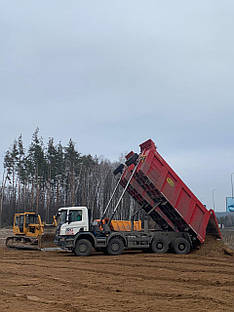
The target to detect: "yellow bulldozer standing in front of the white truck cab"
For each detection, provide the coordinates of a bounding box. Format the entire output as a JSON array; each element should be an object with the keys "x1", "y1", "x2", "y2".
[{"x1": 6, "y1": 212, "x2": 57, "y2": 250}]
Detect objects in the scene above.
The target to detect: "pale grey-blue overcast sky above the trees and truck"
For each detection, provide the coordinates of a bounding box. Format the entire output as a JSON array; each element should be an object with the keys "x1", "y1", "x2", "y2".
[{"x1": 0, "y1": 0, "x2": 234, "y2": 211}]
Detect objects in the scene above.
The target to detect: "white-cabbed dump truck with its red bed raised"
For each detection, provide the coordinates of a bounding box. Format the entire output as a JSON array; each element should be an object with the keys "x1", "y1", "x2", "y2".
[{"x1": 55, "y1": 140, "x2": 222, "y2": 256}]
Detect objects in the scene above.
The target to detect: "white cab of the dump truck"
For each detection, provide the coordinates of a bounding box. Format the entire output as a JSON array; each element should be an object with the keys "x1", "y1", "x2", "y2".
[{"x1": 58, "y1": 206, "x2": 89, "y2": 236}]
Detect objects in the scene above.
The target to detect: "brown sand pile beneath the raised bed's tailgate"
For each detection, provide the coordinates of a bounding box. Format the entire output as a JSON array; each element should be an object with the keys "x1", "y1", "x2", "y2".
[{"x1": 194, "y1": 235, "x2": 234, "y2": 257}]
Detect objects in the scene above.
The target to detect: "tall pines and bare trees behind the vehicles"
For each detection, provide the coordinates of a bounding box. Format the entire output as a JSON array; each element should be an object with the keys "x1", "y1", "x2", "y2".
[{"x1": 0, "y1": 128, "x2": 137, "y2": 225}]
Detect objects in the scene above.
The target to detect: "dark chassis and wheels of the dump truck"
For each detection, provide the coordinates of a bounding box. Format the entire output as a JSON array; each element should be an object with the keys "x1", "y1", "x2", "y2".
[{"x1": 56, "y1": 231, "x2": 193, "y2": 256}]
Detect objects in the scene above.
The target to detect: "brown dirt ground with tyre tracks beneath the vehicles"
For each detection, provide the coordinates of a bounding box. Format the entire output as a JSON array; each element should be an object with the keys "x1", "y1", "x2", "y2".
[{"x1": 0, "y1": 231, "x2": 234, "y2": 312}]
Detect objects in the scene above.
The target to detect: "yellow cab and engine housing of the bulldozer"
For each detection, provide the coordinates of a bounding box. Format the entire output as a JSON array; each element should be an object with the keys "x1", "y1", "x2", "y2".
[{"x1": 13, "y1": 212, "x2": 44, "y2": 238}]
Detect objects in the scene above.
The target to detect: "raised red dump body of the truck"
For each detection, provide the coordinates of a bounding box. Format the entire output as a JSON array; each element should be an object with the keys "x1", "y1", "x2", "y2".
[{"x1": 120, "y1": 140, "x2": 221, "y2": 243}]
